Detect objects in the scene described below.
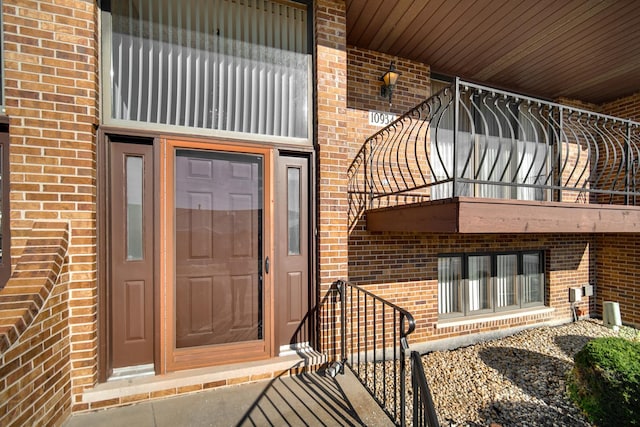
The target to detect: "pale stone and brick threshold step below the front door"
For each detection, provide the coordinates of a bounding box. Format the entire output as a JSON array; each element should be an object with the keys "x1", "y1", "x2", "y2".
[{"x1": 82, "y1": 348, "x2": 327, "y2": 409}]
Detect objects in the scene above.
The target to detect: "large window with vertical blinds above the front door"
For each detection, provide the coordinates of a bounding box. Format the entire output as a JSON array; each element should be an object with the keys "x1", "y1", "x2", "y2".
[{"x1": 103, "y1": 0, "x2": 311, "y2": 139}]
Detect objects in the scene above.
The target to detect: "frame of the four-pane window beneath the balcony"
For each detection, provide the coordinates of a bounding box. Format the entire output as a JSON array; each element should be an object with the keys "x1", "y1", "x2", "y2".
[{"x1": 437, "y1": 250, "x2": 547, "y2": 320}]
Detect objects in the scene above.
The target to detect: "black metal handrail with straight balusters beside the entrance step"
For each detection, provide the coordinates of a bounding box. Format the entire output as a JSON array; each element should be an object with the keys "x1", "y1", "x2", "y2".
[{"x1": 336, "y1": 281, "x2": 424, "y2": 426}]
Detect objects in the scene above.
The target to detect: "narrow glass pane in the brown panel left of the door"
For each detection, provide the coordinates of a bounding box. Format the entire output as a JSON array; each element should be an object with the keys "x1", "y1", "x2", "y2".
[{"x1": 125, "y1": 156, "x2": 144, "y2": 261}]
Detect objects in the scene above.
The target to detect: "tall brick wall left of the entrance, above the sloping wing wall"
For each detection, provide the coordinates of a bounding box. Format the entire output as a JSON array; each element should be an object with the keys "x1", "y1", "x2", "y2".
[{"x1": 2, "y1": 0, "x2": 99, "y2": 414}]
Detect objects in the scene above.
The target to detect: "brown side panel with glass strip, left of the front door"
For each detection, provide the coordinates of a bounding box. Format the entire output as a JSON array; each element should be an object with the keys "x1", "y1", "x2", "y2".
[{"x1": 109, "y1": 142, "x2": 154, "y2": 368}]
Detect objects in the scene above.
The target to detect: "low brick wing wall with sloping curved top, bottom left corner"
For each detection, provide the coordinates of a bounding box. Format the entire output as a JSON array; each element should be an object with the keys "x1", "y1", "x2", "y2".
[{"x1": 0, "y1": 222, "x2": 71, "y2": 426}]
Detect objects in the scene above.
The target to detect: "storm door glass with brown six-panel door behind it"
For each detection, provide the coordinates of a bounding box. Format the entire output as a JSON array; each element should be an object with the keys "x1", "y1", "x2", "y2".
[{"x1": 175, "y1": 149, "x2": 264, "y2": 348}]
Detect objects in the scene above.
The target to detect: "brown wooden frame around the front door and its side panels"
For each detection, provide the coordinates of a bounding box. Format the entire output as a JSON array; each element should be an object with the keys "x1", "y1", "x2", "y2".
[{"x1": 97, "y1": 126, "x2": 321, "y2": 383}]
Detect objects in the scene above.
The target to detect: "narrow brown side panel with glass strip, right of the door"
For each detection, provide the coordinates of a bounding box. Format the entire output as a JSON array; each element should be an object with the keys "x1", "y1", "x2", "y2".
[{"x1": 274, "y1": 156, "x2": 309, "y2": 348}]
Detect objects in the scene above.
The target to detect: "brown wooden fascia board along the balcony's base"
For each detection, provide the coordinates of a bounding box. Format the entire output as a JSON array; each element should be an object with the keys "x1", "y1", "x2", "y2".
[{"x1": 367, "y1": 197, "x2": 640, "y2": 234}]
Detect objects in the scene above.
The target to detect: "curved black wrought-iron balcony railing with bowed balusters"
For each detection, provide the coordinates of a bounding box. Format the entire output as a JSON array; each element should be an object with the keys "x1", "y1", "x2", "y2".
[{"x1": 348, "y1": 79, "x2": 640, "y2": 229}]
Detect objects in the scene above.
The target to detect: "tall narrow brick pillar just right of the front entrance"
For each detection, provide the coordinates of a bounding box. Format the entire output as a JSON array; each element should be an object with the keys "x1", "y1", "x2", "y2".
[{"x1": 314, "y1": 0, "x2": 349, "y2": 358}]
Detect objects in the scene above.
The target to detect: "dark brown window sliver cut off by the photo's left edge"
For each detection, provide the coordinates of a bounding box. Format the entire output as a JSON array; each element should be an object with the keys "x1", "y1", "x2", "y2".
[{"x1": 0, "y1": 120, "x2": 11, "y2": 289}]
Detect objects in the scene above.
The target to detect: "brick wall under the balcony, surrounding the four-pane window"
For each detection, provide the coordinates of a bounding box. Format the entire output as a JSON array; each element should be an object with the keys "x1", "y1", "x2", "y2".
[{"x1": 349, "y1": 221, "x2": 595, "y2": 342}]
